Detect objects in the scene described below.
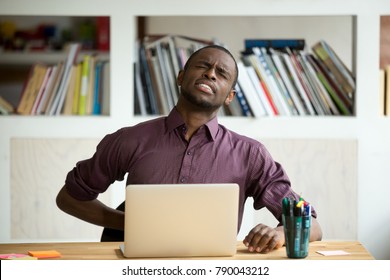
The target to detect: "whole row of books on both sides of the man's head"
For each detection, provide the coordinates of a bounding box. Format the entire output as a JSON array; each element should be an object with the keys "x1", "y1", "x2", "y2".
[{"x1": 134, "y1": 35, "x2": 355, "y2": 117}]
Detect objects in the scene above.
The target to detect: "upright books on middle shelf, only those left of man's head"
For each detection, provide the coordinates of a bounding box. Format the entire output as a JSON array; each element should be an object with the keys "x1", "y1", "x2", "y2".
[{"x1": 134, "y1": 34, "x2": 212, "y2": 114}]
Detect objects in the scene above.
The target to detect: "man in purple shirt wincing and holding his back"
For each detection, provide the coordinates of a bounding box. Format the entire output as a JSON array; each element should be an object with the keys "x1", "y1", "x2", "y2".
[{"x1": 57, "y1": 46, "x2": 322, "y2": 253}]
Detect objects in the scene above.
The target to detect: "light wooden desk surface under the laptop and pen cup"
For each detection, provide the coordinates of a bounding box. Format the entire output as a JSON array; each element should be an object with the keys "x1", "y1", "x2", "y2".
[{"x1": 0, "y1": 241, "x2": 374, "y2": 260}]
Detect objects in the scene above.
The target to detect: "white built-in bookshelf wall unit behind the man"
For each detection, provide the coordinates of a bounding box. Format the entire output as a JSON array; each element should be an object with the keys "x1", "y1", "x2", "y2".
[{"x1": 0, "y1": 0, "x2": 390, "y2": 259}]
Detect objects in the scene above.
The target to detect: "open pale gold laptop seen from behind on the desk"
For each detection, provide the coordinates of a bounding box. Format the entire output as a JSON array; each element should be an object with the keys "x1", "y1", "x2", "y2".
[{"x1": 121, "y1": 184, "x2": 239, "y2": 258}]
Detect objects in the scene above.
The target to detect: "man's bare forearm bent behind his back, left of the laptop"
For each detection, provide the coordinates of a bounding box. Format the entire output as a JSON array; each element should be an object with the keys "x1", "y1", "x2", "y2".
[{"x1": 56, "y1": 186, "x2": 125, "y2": 230}]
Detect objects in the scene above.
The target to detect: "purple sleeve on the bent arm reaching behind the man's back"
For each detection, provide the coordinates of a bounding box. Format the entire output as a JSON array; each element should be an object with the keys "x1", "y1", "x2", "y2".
[{"x1": 65, "y1": 130, "x2": 127, "y2": 201}]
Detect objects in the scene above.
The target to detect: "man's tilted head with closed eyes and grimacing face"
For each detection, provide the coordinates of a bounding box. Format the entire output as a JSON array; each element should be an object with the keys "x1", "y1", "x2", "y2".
[{"x1": 178, "y1": 48, "x2": 236, "y2": 110}]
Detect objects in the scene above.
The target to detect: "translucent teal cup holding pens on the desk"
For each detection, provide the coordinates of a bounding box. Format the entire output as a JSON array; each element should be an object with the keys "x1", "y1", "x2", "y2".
[{"x1": 282, "y1": 215, "x2": 311, "y2": 259}]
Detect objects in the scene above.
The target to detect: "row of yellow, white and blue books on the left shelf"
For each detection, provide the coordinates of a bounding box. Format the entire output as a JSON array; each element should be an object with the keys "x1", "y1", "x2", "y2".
[{"x1": 16, "y1": 43, "x2": 109, "y2": 115}]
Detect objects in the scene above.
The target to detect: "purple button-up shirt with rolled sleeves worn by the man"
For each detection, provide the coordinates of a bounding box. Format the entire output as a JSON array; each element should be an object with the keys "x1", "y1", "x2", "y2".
[{"x1": 65, "y1": 109, "x2": 316, "y2": 230}]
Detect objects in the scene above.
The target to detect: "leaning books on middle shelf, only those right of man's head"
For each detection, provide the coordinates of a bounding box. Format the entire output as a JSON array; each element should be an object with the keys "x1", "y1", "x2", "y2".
[{"x1": 238, "y1": 39, "x2": 355, "y2": 117}]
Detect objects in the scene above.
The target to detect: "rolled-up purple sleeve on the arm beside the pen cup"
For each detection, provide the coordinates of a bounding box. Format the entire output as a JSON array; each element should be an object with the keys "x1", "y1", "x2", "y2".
[{"x1": 250, "y1": 144, "x2": 317, "y2": 225}]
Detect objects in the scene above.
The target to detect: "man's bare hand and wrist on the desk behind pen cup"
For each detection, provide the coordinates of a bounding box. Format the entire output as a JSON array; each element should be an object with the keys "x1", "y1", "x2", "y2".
[{"x1": 243, "y1": 217, "x2": 322, "y2": 253}]
